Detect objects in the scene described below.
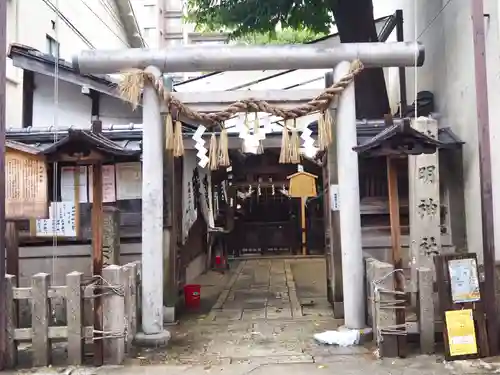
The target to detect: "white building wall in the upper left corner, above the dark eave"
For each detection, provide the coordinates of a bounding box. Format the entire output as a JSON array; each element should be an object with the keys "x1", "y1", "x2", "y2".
[{"x1": 7, "y1": 0, "x2": 134, "y2": 127}]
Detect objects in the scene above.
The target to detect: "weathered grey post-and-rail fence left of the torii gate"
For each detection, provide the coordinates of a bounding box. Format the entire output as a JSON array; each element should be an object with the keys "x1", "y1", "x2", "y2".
[{"x1": 5, "y1": 263, "x2": 139, "y2": 368}]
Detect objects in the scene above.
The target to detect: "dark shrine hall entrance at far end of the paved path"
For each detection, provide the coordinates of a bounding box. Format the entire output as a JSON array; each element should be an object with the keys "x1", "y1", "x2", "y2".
[{"x1": 222, "y1": 148, "x2": 324, "y2": 257}]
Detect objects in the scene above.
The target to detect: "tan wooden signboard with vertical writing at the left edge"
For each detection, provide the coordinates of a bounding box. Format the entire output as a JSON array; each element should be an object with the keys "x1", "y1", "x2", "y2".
[{"x1": 5, "y1": 141, "x2": 49, "y2": 220}]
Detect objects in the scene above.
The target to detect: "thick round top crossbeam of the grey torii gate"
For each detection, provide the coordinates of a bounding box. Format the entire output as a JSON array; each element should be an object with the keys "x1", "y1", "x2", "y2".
[{"x1": 73, "y1": 42, "x2": 425, "y2": 74}]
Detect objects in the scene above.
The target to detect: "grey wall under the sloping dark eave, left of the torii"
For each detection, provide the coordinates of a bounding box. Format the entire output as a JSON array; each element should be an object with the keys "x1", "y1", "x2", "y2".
[{"x1": 33, "y1": 74, "x2": 142, "y2": 128}]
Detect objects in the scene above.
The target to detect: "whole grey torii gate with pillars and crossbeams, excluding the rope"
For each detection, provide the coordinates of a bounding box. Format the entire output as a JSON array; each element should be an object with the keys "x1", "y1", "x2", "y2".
[{"x1": 73, "y1": 42, "x2": 425, "y2": 342}]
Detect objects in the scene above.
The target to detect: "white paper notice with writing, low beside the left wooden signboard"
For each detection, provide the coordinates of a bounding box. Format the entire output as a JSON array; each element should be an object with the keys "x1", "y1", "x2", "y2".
[{"x1": 36, "y1": 202, "x2": 77, "y2": 237}]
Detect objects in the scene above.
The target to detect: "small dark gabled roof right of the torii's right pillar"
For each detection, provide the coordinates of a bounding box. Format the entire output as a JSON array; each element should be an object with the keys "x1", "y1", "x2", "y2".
[{"x1": 353, "y1": 119, "x2": 449, "y2": 156}]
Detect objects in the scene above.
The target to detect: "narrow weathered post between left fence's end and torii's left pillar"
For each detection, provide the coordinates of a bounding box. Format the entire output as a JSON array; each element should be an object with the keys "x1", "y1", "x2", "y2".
[{"x1": 123, "y1": 263, "x2": 137, "y2": 353}]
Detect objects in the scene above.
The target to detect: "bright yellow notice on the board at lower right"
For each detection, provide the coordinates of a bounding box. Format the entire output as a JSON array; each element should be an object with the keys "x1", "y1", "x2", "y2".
[{"x1": 445, "y1": 309, "x2": 477, "y2": 357}]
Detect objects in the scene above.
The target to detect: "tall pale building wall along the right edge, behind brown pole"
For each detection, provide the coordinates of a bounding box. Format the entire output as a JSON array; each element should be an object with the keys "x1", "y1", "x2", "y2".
[{"x1": 374, "y1": 0, "x2": 500, "y2": 258}]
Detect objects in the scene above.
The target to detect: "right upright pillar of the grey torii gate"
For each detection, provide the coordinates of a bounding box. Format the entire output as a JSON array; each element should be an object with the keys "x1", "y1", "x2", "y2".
[{"x1": 334, "y1": 61, "x2": 366, "y2": 329}]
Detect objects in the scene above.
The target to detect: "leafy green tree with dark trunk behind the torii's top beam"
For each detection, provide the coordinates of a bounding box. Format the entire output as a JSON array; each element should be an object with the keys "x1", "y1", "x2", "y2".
[{"x1": 187, "y1": 0, "x2": 389, "y2": 118}]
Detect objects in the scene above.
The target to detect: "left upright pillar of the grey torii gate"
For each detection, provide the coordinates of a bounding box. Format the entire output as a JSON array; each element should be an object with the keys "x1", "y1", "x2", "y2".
[{"x1": 142, "y1": 66, "x2": 164, "y2": 335}]
